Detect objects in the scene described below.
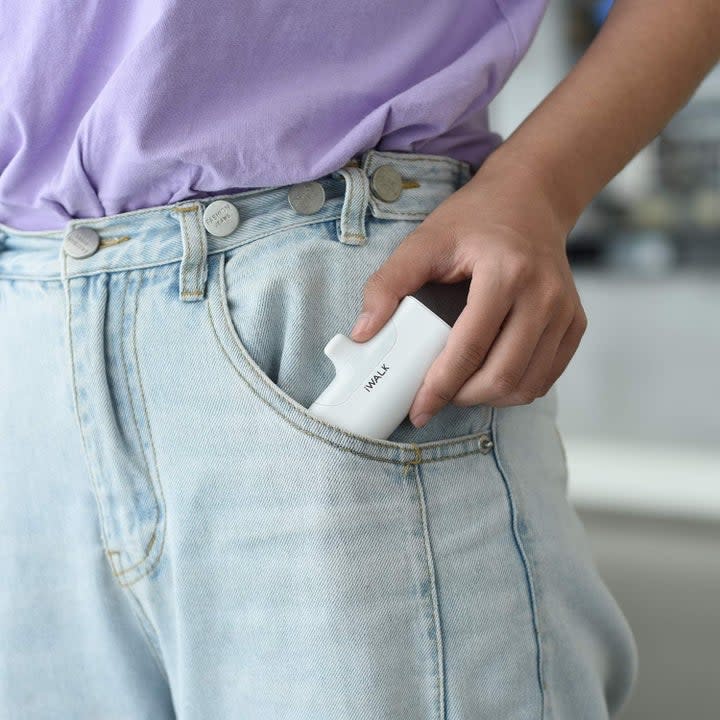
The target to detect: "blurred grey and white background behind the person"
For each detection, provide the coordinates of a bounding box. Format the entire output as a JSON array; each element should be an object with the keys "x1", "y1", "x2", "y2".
[{"x1": 490, "y1": 0, "x2": 720, "y2": 720}]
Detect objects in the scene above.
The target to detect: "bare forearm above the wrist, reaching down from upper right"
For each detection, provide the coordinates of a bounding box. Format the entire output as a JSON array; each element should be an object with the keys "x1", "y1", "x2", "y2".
[{"x1": 471, "y1": 0, "x2": 720, "y2": 232}]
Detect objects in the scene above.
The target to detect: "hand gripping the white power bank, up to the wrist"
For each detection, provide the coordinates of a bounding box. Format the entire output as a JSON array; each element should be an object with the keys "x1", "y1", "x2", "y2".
[{"x1": 351, "y1": 151, "x2": 587, "y2": 427}]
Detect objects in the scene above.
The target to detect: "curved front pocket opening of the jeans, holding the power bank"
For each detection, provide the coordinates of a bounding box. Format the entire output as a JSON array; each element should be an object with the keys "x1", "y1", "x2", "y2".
[{"x1": 207, "y1": 221, "x2": 492, "y2": 462}]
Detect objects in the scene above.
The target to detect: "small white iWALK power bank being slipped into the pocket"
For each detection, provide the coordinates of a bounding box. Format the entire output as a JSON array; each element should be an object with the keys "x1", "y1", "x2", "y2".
[{"x1": 308, "y1": 295, "x2": 452, "y2": 440}]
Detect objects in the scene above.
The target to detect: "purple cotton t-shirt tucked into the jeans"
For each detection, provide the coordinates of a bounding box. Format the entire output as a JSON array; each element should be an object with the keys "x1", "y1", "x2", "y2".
[{"x1": 0, "y1": 0, "x2": 548, "y2": 230}]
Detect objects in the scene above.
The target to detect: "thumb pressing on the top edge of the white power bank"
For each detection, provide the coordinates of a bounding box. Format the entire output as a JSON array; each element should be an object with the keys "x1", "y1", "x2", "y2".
[{"x1": 350, "y1": 230, "x2": 439, "y2": 342}]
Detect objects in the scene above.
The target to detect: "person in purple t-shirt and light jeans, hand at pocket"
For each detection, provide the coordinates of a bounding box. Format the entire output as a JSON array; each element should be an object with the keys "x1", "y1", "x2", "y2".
[{"x1": 0, "y1": 0, "x2": 720, "y2": 720}]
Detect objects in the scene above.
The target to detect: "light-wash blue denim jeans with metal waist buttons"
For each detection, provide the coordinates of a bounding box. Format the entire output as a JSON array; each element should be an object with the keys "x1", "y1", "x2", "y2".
[{"x1": 0, "y1": 149, "x2": 637, "y2": 720}]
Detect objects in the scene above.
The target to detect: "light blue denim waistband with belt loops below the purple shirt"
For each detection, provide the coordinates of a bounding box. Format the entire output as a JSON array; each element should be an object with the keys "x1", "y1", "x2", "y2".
[{"x1": 0, "y1": 148, "x2": 474, "y2": 284}]
